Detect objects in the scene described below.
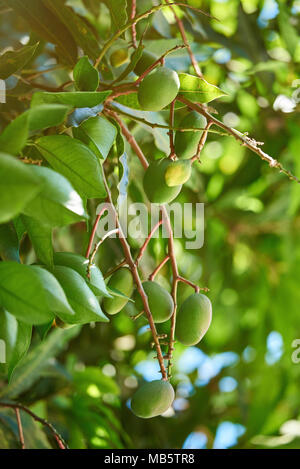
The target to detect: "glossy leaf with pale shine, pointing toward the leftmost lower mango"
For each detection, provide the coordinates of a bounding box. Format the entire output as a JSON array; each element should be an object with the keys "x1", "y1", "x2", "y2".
[{"x1": 49, "y1": 266, "x2": 109, "y2": 324}]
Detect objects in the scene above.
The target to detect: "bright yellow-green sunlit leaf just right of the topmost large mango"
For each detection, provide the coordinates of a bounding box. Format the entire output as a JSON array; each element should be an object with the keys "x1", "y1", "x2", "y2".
[{"x1": 179, "y1": 73, "x2": 226, "y2": 103}]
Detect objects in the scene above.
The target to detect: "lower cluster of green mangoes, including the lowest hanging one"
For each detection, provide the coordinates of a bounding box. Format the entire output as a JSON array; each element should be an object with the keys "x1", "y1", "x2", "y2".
[{"x1": 103, "y1": 267, "x2": 212, "y2": 419}]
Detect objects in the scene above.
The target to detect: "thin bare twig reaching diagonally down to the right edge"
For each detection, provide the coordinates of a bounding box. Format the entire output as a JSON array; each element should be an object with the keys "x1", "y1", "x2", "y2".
[{"x1": 177, "y1": 95, "x2": 300, "y2": 184}]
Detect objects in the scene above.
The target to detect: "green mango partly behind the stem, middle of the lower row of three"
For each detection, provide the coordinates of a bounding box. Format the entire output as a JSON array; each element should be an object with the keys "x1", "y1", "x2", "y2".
[{"x1": 134, "y1": 282, "x2": 174, "y2": 324}]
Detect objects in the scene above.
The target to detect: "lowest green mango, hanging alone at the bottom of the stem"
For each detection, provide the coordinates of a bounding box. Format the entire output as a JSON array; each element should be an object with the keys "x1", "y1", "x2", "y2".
[{"x1": 131, "y1": 380, "x2": 175, "y2": 419}]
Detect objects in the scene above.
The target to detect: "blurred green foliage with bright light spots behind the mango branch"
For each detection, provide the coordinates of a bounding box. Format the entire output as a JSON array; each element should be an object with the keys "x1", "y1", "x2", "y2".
[{"x1": 0, "y1": 0, "x2": 300, "y2": 449}]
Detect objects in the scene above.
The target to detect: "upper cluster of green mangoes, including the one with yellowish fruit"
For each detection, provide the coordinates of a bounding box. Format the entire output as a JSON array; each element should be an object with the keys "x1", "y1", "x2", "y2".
[{"x1": 135, "y1": 51, "x2": 207, "y2": 204}]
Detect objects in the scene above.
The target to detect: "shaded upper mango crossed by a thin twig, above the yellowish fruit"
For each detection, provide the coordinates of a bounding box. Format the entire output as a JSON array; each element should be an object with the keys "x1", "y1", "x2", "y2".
[{"x1": 174, "y1": 111, "x2": 207, "y2": 160}]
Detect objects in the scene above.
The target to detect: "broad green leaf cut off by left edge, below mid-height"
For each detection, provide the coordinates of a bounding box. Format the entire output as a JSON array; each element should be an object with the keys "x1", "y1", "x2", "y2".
[{"x1": 0, "y1": 262, "x2": 54, "y2": 325}]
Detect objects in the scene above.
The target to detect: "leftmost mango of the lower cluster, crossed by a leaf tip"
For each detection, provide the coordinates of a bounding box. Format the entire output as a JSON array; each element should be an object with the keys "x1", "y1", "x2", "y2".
[{"x1": 103, "y1": 268, "x2": 133, "y2": 315}]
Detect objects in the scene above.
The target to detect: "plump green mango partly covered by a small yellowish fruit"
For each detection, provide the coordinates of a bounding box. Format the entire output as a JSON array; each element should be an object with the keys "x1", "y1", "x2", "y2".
[{"x1": 143, "y1": 158, "x2": 182, "y2": 204}]
